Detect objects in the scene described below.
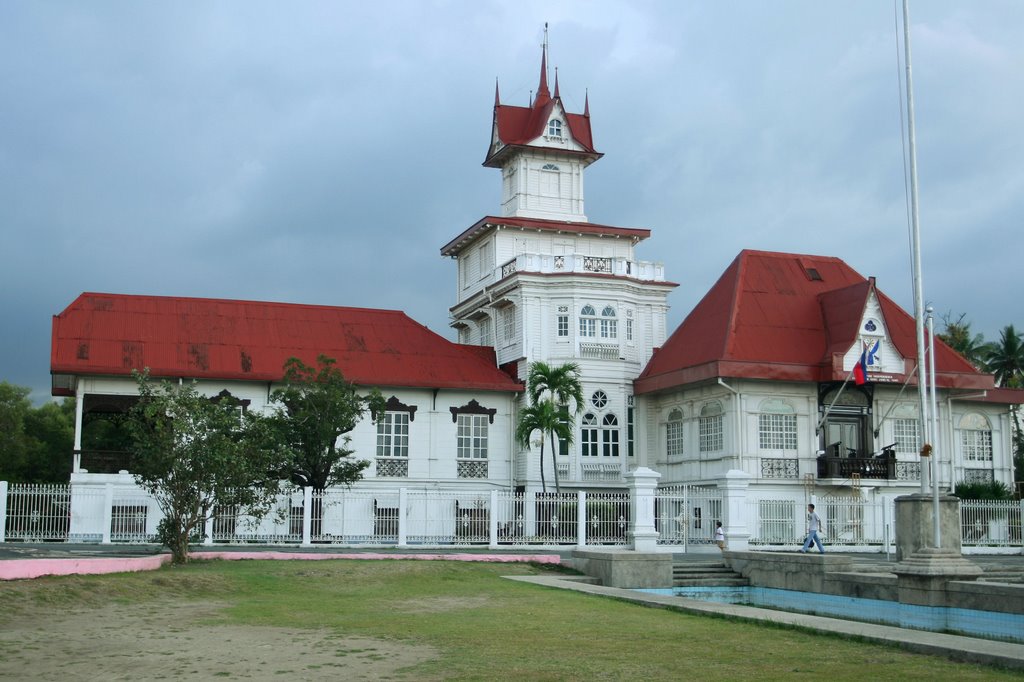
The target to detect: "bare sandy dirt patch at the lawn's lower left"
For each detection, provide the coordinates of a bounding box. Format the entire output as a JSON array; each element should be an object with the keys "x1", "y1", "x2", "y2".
[{"x1": 0, "y1": 602, "x2": 437, "y2": 682}]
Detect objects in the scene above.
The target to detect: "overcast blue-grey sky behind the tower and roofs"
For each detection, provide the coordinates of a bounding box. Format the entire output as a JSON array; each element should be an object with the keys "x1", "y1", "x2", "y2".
[{"x1": 0, "y1": 0, "x2": 1024, "y2": 401}]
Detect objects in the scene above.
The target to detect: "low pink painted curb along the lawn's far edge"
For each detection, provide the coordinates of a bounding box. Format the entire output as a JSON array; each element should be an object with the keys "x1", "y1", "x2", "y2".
[{"x1": 0, "y1": 551, "x2": 561, "y2": 581}]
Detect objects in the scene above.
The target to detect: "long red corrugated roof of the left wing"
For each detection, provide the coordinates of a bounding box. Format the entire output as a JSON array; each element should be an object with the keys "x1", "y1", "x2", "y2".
[{"x1": 50, "y1": 293, "x2": 522, "y2": 391}]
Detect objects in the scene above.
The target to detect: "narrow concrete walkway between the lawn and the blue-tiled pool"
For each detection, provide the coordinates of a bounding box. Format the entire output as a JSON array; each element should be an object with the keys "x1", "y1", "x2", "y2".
[{"x1": 508, "y1": 576, "x2": 1024, "y2": 671}]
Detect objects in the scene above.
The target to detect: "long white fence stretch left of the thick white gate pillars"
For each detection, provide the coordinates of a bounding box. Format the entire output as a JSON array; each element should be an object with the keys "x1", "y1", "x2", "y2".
[{"x1": 0, "y1": 482, "x2": 630, "y2": 547}]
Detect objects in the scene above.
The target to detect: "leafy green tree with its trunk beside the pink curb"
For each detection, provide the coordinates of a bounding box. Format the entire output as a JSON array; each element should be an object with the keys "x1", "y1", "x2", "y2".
[{"x1": 126, "y1": 373, "x2": 286, "y2": 563}]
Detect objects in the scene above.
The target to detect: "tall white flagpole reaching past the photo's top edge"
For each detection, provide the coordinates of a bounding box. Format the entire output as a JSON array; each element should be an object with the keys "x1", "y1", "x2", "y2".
[{"x1": 903, "y1": 0, "x2": 930, "y2": 494}]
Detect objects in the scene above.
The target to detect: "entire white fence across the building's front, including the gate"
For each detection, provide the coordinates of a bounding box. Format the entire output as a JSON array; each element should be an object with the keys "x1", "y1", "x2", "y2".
[{"x1": 0, "y1": 481, "x2": 1024, "y2": 552}]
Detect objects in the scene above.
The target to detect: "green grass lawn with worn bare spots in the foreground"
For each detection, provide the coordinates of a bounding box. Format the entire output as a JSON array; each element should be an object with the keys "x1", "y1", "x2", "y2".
[{"x1": 0, "y1": 560, "x2": 1020, "y2": 681}]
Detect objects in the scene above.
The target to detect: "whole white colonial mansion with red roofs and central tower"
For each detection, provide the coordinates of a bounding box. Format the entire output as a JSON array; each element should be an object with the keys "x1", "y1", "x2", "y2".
[{"x1": 44, "y1": 45, "x2": 1024, "y2": 535}]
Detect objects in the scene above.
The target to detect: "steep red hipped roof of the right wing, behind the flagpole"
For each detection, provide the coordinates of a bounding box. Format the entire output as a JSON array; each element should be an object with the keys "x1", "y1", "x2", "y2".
[{"x1": 636, "y1": 251, "x2": 992, "y2": 393}]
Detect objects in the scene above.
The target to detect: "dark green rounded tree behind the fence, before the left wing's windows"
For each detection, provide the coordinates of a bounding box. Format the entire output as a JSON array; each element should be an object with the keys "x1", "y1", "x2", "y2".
[{"x1": 270, "y1": 355, "x2": 385, "y2": 492}]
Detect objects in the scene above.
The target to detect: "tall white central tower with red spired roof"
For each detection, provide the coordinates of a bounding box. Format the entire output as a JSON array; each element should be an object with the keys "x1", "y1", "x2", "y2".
[{"x1": 441, "y1": 41, "x2": 676, "y2": 491}]
